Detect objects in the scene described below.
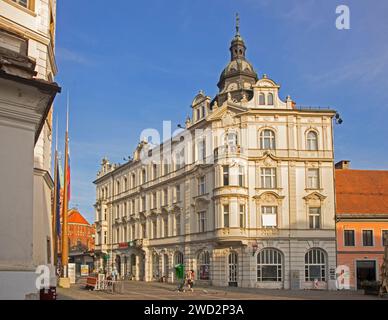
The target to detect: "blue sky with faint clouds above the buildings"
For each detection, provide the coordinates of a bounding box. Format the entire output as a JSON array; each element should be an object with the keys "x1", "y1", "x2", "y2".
[{"x1": 54, "y1": 0, "x2": 388, "y2": 221}]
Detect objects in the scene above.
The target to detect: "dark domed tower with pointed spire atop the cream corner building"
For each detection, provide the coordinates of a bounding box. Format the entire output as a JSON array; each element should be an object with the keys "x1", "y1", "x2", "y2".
[{"x1": 217, "y1": 14, "x2": 258, "y2": 105}]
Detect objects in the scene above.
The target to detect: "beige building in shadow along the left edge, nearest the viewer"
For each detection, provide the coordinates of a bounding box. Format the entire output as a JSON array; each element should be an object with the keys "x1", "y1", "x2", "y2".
[{"x1": 0, "y1": 0, "x2": 60, "y2": 299}]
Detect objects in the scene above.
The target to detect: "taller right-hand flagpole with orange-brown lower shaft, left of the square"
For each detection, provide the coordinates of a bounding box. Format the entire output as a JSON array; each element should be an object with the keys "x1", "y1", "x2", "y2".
[{"x1": 60, "y1": 94, "x2": 70, "y2": 288}]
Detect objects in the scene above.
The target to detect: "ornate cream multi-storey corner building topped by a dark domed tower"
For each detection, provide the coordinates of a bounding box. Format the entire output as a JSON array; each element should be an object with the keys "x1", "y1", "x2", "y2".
[{"x1": 94, "y1": 23, "x2": 336, "y2": 289}]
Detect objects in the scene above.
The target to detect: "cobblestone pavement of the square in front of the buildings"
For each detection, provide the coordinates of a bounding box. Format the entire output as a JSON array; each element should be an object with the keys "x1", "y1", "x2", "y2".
[{"x1": 57, "y1": 281, "x2": 388, "y2": 300}]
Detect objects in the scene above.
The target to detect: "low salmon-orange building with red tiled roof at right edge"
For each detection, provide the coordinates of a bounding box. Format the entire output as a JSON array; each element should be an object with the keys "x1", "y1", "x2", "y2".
[{"x1": 335, "y1": 161, "x2": 388, "y2": 289}]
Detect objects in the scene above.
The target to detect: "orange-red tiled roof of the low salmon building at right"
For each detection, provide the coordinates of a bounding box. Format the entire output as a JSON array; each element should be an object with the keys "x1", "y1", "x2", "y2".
[{"x1": 335, "y1": 169, "x2": 388, "y2": 214}]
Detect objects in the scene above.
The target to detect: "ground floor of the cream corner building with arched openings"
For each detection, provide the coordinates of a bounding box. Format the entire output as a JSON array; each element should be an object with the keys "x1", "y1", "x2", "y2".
[{"x1": 96, "y1": 239, "x2": 336, "y2": 289}]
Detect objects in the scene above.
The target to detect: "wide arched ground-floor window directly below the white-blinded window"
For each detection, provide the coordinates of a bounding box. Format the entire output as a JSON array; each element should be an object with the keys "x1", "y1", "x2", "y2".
[{"x1": 257, "y1": 249, "x2": 282, "y2": 281}]
